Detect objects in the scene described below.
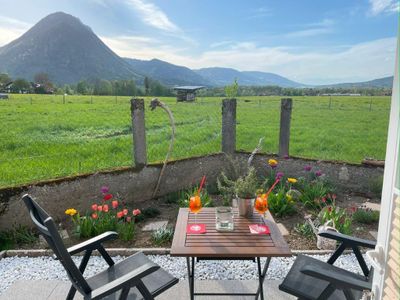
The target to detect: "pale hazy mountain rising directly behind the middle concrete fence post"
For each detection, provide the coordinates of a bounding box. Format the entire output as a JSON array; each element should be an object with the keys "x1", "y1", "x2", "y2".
[{"x1": 194, "y1": 67, "x2": 305, "y2": 87}]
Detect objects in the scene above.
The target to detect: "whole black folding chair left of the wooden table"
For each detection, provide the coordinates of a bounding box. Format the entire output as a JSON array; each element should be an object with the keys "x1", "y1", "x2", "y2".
[{"x1": 22, "y1": 195, "x2": 178, "y2": 300}]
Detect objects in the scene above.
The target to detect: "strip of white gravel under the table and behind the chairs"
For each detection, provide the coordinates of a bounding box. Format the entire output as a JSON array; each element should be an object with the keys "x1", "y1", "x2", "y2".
[{"x1": 0, "y1": 254, "x2": 370, "y2": 295}]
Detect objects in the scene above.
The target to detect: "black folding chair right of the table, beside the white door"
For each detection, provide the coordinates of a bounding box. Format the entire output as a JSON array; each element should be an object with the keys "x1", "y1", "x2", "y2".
[{"x1": 279, "y1": 231, "x2": 375, "y2": 300}]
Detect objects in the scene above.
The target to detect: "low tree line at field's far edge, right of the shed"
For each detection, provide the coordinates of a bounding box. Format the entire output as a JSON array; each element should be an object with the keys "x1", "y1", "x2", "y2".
[{"x1": 198, "y1": 86, "x2": 392, "y2": 97}]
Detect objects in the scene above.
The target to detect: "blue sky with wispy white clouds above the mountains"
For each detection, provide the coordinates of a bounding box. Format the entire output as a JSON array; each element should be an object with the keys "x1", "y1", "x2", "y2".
[{"x1": 0, "y1": 0, "x2": 399, "y2": 84}]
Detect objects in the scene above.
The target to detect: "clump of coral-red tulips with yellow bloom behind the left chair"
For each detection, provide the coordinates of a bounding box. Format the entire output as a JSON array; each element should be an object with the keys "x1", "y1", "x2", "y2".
[{"x1": 65, "y1": 187, "x2": 141, "y2": 241}]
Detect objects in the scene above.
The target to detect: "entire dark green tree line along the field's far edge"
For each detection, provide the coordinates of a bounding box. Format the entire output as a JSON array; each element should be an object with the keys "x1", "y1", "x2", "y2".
[{"x1": 0, "y1": 73, "x2": 392, "y2": 97}]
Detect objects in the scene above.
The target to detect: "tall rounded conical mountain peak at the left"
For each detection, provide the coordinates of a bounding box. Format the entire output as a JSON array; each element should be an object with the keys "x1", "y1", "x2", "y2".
[{"x1": 0, "y1": 12, "x2": 141, "y2": 84}]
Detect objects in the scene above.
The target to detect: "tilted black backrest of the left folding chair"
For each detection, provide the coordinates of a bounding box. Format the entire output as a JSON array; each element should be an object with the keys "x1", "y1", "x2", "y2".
[{"x1": 22, "y1": 195, "x2": 92, "y2": 295}]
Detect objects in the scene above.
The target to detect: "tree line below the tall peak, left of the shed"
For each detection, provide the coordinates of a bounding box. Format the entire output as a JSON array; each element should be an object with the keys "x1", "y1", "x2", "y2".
[{"x1": 0, "y1": 73, "x2": 174, "y2": 96}]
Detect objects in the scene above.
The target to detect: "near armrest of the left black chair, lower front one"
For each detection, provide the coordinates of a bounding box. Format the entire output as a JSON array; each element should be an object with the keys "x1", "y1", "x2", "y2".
[{"x1": 90, "y1": 262, "x2": 160, "y2": 300}]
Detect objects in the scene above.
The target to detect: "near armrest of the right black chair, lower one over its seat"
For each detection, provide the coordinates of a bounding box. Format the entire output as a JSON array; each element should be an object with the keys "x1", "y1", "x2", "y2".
[{"x1": 300, "y1": 266, "x2": 372, "y2": 291}]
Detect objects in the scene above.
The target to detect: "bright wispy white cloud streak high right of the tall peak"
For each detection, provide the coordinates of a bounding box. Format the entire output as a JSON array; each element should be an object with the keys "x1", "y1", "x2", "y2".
[{"x1": 125, "y1": 0, "x2": 182, "y2": 33}]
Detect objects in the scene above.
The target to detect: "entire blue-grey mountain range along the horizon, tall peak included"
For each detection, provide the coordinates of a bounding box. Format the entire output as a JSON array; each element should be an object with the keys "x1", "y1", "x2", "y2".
[{"x1": 0, "y1": 12, "x2": 393, "y2": 88}]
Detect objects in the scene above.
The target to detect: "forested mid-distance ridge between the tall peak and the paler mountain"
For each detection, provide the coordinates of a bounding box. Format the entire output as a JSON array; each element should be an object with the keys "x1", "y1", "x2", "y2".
[{"x1": 125, "y1": 58, "x2": 214, "y2": 86}]
